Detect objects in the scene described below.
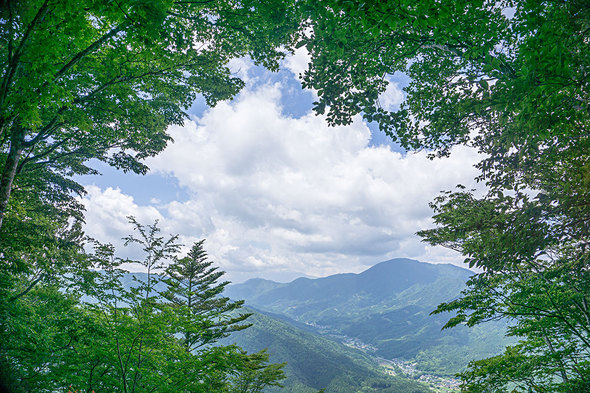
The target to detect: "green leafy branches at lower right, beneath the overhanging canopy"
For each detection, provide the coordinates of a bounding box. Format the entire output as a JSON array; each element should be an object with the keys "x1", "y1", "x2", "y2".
[{"x1": 423, "y1": 188, "x2": 590, "y2": 392}]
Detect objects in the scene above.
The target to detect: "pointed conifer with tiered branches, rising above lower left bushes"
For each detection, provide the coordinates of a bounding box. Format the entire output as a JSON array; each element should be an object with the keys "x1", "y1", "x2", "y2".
[{"x1": 162, "y1": 240, "x2": 252, "y2": 351}]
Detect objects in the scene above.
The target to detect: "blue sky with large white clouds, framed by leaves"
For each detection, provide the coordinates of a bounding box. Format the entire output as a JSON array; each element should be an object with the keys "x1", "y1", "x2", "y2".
[{"x1": 77, "y1": 48, "x2": 480, "y2": 283}]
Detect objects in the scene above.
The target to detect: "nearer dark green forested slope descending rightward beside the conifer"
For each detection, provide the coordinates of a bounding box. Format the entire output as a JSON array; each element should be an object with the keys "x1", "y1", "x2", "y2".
[{"x1": 220, "y1": 309, "x2": 431, "y2": 393}]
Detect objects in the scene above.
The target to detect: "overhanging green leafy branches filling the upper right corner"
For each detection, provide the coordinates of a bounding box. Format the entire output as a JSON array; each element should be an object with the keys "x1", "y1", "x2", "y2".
[{"x1": 299, "y1": 0, "x2": 589, "y2": 160}]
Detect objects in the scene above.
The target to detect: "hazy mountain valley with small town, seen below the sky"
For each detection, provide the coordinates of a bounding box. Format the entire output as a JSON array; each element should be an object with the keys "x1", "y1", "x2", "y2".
[{"x1": 224, "y1": 259, "x2": 508, "y2": 393}]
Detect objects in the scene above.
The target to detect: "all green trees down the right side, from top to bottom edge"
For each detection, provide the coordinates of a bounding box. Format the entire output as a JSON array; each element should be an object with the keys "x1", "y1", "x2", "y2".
[{"x1": 299, "y1": 0, "x2": 590, "y2": 392}]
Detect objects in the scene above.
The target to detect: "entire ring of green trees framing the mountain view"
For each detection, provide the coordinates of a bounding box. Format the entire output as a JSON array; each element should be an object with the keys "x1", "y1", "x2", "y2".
[{"x1": 0, "y1": 0, "x2": 590, "y2": 393}]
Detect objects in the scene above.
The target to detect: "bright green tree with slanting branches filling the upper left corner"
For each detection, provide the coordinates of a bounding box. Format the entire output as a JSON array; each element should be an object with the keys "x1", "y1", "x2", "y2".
[{"x1": 0, "y1": 0, "x2": 297, "y2": 227}]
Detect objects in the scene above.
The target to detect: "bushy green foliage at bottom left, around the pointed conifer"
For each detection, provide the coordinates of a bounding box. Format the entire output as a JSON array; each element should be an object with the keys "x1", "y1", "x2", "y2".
[{"x1": 0, "y1": 217, "x2": 284, "y2": 393}]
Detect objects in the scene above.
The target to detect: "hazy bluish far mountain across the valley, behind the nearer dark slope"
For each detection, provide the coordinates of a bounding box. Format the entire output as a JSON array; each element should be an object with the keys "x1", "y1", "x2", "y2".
[{"x1": 225, "y1": 259, "x2": 507, "y2": 376}]
